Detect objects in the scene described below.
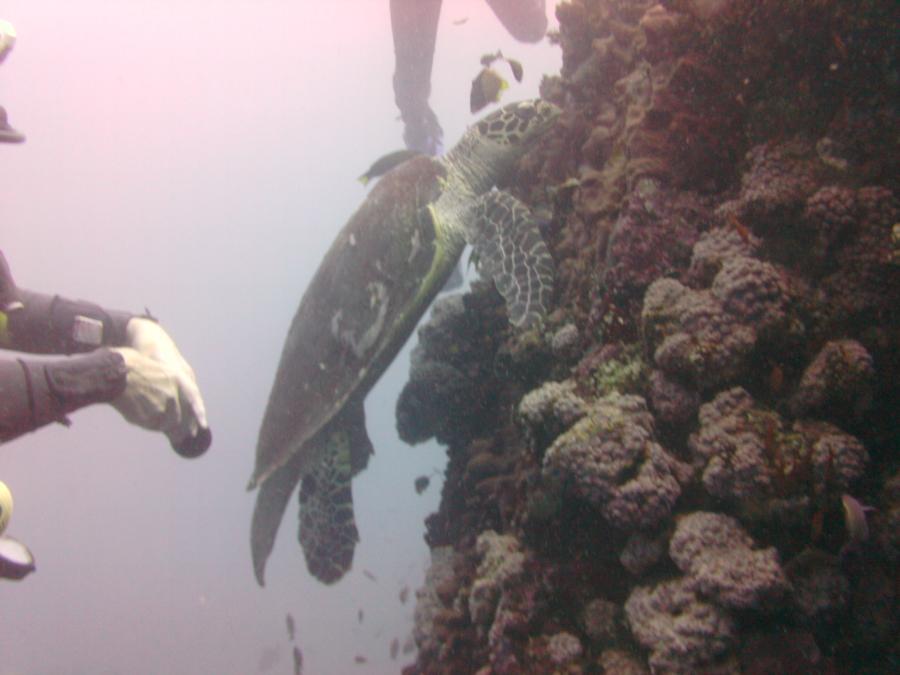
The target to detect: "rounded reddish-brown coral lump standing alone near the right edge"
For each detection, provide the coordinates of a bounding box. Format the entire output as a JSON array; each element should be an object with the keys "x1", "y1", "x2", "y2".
[{"x1": 791, "y1": 340, "x2": 875, "y2": 417}]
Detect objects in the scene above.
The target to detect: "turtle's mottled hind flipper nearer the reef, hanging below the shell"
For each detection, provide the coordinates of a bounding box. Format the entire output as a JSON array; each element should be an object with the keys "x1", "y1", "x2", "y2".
[{"x1": 298, "y1": 402, "x2": 372, "y2": 584}]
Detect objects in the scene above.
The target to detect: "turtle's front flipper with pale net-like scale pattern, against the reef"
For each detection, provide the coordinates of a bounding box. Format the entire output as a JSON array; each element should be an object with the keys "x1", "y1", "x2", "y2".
[{"x1": 470, "y1": 191, "x2": 553, "y2": 328}]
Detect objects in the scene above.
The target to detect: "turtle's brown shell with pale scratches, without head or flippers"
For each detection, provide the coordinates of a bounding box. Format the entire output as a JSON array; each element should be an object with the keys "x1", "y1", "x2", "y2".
[{"x1": 251, "y1": 156, "x2": 460, "y2": 487}]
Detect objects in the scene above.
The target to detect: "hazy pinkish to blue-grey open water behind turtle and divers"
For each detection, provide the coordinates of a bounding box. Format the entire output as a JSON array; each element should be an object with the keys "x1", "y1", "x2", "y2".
[{"x1": 0, "y1": 0, "x2": 560, "y2": 675}]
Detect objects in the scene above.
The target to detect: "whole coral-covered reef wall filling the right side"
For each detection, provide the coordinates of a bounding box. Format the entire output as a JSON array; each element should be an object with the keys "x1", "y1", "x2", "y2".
[{"x1": 397, "y1": 0, "x2": 900, "y2": 675}]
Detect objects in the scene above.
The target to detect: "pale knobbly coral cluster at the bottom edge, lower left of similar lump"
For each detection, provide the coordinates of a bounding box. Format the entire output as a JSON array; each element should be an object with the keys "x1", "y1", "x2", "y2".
[{"x1": 625, "y1": 578, "x2": 736, "y2": 674}]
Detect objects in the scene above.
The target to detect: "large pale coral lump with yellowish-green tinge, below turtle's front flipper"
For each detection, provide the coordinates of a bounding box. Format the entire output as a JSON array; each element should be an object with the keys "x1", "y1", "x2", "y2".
[{"x1": 544, "y1": 393, "x2": 689, "y2": 529}]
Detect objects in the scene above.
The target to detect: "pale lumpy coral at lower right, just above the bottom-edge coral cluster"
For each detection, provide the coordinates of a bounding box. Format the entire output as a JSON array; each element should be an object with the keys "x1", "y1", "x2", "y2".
[{"x1": 669, "y1": 511, "x2": 790, "y2": 609}]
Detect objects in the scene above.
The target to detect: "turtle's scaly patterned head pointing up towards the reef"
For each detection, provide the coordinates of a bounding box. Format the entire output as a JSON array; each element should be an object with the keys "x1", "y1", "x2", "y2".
[{"x1": 453, "y1": 98, "x2": 561, "y2": 178}]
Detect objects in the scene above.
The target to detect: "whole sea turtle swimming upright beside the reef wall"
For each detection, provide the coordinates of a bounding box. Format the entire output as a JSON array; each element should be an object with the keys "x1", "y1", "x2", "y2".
[{"x1": 248, "y1": 99, "x2": 559, "y2": 585}]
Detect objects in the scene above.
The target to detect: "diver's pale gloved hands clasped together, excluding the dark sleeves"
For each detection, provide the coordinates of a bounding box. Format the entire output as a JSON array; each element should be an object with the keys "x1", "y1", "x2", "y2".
[{"x1": 112, "y1": 317, "x2": 212, "y2": 457}]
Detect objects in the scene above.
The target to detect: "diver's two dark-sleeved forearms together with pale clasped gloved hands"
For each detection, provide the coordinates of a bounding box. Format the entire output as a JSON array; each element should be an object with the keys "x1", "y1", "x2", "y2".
[{"x1": 0, "y1": 252, "x2": 212, "y2": 457}]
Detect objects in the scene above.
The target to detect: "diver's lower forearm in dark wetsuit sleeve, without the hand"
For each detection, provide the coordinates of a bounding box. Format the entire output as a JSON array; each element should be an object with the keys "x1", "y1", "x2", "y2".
[{"x1": 0, "y1": 349, "x2": 128, "y2": 442}]
